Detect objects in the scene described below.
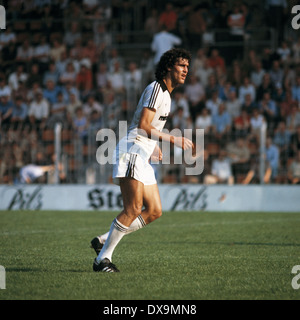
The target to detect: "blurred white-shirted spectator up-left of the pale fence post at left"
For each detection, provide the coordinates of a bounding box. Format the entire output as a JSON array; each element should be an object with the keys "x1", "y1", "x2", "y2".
[{"x1": 28, "y1": 89, "x2": 49, "y2": 130}]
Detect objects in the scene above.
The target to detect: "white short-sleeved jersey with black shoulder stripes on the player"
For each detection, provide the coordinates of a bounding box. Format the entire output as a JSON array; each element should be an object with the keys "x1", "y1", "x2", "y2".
[{"x1": 117, "y1": 81, "x2": 171, "y2": 159}]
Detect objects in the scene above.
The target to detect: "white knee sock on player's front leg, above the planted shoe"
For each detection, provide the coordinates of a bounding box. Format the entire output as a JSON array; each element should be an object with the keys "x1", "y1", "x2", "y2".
[{"x1": 96, "y1": 219, "x2": 128, "y2": 263}]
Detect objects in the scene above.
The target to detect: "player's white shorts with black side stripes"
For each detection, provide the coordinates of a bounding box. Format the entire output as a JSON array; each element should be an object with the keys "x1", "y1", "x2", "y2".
[{"x1": 113, "y1": 152, "x2": 157, "y2": 185}]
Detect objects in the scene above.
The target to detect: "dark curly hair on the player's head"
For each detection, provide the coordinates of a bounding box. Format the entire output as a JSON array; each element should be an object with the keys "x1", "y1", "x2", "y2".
[{"x1": 155, "y1": 48, "x2": 192, "y2": 80}]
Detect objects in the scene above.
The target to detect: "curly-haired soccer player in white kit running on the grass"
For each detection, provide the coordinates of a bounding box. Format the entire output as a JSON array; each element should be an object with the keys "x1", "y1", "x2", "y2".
[{"x1": 91, "y1": 48, "x2": 193, "y2": 272}]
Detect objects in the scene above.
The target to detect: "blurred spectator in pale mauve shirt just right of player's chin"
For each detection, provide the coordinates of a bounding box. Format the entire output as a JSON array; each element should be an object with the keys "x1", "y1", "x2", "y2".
[{"x1": 185, "y1": 74, "x2": 205, "y2": 120}]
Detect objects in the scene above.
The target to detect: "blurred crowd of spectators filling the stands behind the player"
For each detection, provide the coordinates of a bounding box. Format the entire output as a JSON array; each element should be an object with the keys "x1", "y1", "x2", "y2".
[{"x1": 0, "y1": 0, "x2": 300, "y2": 184}]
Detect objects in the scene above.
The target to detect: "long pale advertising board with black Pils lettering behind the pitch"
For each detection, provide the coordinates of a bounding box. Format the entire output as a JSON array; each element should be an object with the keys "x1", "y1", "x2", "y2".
[{"x1": 0, "y1": 184, "x2": 300, "y2": 212}]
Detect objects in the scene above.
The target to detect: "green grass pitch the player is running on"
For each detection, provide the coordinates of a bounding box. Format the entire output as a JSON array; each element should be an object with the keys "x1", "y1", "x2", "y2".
[{"x1": 0, "y1": 211, "x2": 300, "y2": 300}]
